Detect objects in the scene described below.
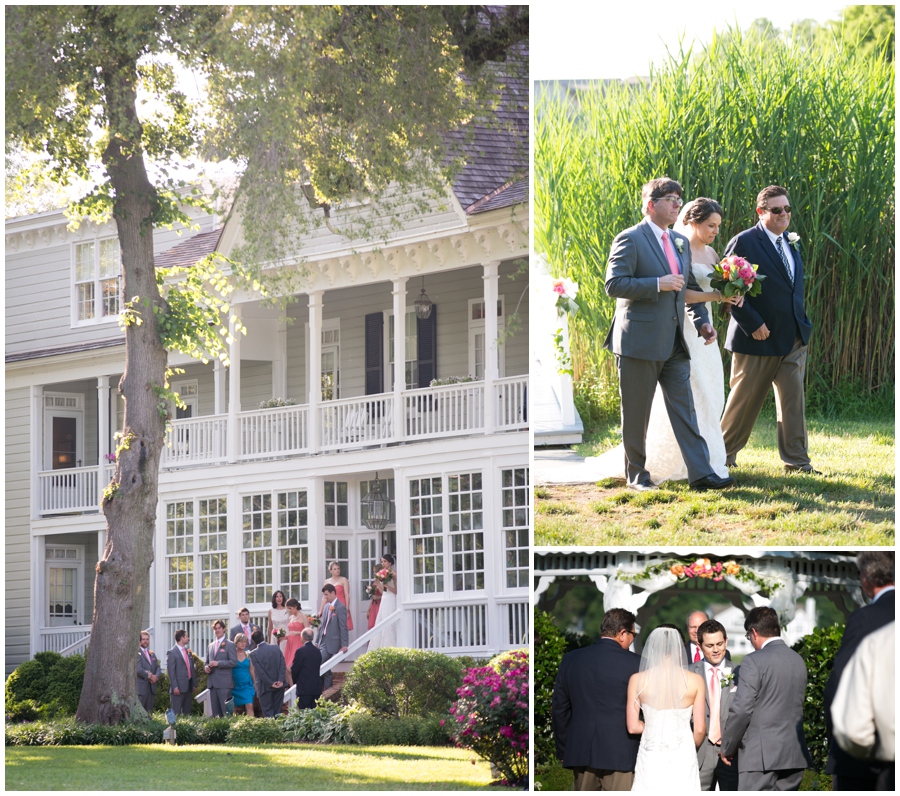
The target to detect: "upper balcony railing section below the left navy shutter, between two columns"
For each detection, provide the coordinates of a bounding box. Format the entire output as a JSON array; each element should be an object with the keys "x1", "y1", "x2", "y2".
[{"x1": 318, "y1": 394, "x2": 394, "y2": 450}]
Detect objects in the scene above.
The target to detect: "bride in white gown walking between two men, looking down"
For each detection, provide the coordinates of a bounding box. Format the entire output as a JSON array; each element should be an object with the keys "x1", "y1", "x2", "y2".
[{"x1": 584, "y1": 197, "x2": 740, "y2": 484}]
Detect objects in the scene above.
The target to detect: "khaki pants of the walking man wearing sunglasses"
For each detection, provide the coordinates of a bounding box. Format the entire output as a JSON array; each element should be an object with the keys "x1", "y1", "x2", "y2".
[{"x1": 722, "y1": 337, "x2": 810, "y2": 467}]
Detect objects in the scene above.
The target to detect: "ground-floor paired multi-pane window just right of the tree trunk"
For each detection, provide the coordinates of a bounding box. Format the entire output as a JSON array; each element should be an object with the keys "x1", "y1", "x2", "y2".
[{"x1": 166, "y1": 498, "x2": 228, "y2": 608}]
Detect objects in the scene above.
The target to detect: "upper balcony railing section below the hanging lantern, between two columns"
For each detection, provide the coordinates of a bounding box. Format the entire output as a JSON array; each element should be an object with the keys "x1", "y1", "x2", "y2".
[{"x1": 403, "y1": 381, "x2": 484, "y2": 439}]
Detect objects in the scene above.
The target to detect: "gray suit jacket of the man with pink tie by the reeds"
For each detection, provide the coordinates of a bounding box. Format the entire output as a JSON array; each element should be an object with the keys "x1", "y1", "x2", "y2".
[{"x1": 603, "y1": 218, "x2": 709, "y2": 362}]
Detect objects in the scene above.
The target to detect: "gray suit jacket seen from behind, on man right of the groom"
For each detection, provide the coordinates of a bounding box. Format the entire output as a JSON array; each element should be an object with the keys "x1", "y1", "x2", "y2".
[{"x1": 722, "y1": 639, "x2": 812, "y2": 772}]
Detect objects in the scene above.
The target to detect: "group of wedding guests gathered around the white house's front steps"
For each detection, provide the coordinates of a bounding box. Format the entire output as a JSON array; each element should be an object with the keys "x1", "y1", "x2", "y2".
[{"x1": 137, "y1": 554, "x2": 396, "y2": 716}]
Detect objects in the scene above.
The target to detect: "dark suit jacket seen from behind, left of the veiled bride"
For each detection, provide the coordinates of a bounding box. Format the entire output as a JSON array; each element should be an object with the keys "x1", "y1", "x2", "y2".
[{"x1": 553, "y1": 638, "x2": 641, "y2": 771}]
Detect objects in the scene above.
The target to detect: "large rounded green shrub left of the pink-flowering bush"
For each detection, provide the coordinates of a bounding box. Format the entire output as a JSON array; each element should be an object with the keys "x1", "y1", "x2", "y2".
[{"x1": 344, "y1": 647, "x2": 462, "y2": 716}]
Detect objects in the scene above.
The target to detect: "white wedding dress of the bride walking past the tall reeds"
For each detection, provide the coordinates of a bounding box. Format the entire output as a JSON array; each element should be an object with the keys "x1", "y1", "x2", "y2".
[{"x1": 584, "y1": 248, "x2": 728, "y2": 484}]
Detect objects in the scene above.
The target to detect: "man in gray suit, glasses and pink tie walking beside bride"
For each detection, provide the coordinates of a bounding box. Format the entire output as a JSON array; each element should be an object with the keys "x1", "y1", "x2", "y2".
[{"x1": 604, "y1": 177, "x2": 734, "y2": 491}]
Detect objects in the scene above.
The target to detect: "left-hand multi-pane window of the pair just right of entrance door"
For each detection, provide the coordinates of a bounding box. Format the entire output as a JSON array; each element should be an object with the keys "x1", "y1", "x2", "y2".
[{"x1": 409, "y1": 478, "x2": 444, "y2": 594}]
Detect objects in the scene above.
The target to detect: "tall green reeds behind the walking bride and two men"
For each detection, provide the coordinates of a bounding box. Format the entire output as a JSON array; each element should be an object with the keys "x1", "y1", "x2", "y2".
[{"x1": 534, "y1": 31, "x2": 895, "y2": 420}]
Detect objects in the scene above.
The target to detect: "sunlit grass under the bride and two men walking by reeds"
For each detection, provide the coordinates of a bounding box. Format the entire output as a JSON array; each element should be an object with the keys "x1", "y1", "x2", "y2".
[{"x1": 534, "y1": 417, "x2": 895, "y2": 547}]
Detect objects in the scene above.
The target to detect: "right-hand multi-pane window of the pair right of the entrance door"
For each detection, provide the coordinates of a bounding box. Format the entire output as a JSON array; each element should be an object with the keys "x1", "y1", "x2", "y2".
[{"x1": 447, "y1": 473, "x2": 484, "y2": 591}]
